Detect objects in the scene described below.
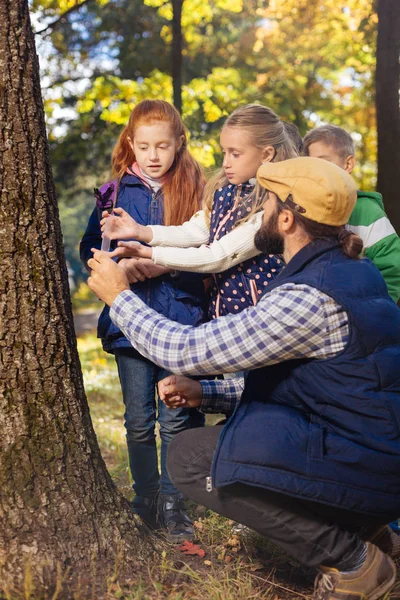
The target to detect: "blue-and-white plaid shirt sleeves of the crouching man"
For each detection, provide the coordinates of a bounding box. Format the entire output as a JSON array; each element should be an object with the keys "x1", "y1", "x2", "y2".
[{"x1": 110, "y1": 283, "x2": 349, "y2": 412}]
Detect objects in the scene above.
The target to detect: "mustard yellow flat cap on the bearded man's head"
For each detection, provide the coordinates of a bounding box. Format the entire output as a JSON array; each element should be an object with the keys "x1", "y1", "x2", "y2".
[{"x1": 257, "y1": 156, "x2": 357, "y2": 227}]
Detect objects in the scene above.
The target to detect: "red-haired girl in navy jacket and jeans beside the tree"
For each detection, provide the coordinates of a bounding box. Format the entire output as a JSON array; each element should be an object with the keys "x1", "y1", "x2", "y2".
[{"x1": 81, "y1": 100, "x2": 204, "y2": 542}]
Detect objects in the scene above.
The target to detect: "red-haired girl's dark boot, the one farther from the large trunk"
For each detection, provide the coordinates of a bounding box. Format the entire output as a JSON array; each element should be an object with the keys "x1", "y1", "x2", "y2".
[{"x1": 158, "y1": 493, "x2": 194, "y2": 544}]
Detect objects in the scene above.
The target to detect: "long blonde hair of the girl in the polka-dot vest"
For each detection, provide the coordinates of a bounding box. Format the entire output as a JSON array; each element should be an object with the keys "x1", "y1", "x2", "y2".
[{"x1": 203, "y1": 104, "x2": 298, "y2": 225}]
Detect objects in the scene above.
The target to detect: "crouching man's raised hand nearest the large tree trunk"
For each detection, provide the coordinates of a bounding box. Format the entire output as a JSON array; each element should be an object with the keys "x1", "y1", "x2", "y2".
[{"x1": 88, "y1": 248, "x2": 129, "y2": 306}]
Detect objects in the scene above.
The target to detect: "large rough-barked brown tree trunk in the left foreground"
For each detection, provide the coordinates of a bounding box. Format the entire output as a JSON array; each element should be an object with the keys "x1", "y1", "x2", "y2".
[{"x1": 0, "y1": 0, "x2": 150, "y2": 595}]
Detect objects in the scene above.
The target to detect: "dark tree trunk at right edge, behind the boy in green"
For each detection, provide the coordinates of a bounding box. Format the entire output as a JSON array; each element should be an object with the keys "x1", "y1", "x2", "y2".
[{"x1": 376, "y1": 0, "x2": 400, "y2": 231}]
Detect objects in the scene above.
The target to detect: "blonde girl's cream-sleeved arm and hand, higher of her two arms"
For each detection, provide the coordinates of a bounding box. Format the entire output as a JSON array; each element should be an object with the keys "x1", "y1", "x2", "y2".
[{"x1": 101, "y1": 208, "x2": 210, "y2": 248}]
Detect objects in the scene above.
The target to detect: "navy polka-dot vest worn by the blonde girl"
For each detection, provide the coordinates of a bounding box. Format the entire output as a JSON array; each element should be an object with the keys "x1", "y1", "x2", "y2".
[{"x1": 208, "y1": 183, "x2": 284, "y2": 319}]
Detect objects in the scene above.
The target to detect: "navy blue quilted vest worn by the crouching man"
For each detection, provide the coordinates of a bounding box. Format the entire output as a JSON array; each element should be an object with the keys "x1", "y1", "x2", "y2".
[{"x1": 211, "y1": 240, "x2": 400, "y2": 516}]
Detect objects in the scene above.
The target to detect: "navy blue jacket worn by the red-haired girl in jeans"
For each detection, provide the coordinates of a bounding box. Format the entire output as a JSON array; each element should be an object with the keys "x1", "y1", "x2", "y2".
[{"x1": 80, "y1": 174, "x2": 205, "y2": 352}]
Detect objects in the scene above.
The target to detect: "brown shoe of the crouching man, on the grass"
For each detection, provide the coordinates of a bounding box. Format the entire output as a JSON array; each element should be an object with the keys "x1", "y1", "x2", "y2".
[{"x1": 312, "y1": 542, "x2": 396, "y2": 600}]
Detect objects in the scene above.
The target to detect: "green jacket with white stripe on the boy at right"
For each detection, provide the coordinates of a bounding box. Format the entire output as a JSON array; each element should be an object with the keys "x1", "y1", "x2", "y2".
[{"x1": 347, "y1": 191, "x2": 400, "y2": 302}]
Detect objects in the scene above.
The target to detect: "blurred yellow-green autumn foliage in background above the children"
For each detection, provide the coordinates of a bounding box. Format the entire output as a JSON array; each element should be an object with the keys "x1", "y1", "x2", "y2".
[{"x1": 31, "y1": 0, "x2": 377, "y2": 267}]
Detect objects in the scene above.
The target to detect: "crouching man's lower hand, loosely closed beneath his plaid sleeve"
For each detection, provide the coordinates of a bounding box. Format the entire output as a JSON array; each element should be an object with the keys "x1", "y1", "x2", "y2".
[{"x1": 158, "y1": 375, "x2": 203, "y2": 408}]
